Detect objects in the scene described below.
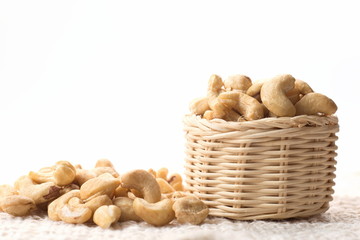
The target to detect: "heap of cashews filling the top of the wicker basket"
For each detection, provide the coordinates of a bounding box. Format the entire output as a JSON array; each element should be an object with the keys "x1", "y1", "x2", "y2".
[{"x1": 190, "y1": 74, "x2": 337, "y2": 122}]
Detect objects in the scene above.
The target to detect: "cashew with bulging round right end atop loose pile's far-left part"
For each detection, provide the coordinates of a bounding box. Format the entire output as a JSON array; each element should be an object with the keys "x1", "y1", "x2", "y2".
[{"x1": 29, "y1": 161, "x2": 76, "y2": 186}]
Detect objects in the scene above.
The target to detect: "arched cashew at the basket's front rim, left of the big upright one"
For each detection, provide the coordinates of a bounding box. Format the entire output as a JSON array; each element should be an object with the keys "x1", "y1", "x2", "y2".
[{"x1": 218, "y1": 92, "x2": 264, "y2": 120}]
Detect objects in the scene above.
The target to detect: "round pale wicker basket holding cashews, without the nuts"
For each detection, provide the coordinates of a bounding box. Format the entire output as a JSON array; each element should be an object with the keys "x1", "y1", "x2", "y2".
[{"x1": 184, "y1": 115, "x2": 339, "y2": 220}]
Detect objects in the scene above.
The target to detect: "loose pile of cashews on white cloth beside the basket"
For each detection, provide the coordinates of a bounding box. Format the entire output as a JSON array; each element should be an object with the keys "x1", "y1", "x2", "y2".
[{"x1": 0, "y1": 159, "x2": 209, "y2": 228}]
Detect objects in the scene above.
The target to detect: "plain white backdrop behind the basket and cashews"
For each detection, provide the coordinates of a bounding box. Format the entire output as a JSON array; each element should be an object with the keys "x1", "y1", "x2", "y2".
[{"x1": 0, "y1": 0, "x2": 360, "y2": 187}]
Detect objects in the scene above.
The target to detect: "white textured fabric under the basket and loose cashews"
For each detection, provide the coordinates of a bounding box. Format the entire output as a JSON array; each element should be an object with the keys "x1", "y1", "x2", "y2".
[{"x1": 0, "y1": 195, "x2": 360, "y2": 240}]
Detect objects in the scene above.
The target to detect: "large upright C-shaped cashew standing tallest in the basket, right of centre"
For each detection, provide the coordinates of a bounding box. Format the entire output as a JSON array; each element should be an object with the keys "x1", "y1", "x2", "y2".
[{"x1": 260, "y1": 74, "x2": 296, "y2": 117}]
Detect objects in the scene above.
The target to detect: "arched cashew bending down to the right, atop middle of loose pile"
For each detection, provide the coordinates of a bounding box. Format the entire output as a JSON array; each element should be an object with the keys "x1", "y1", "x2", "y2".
[{"x1": 121, "y1": 169, "x2": 161, "y2": 203}]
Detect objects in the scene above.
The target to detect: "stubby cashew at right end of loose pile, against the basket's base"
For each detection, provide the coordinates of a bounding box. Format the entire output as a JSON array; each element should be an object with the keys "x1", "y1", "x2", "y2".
[{"x1": 173, "y1": 196, "x2": 209, "y2": 225}]
